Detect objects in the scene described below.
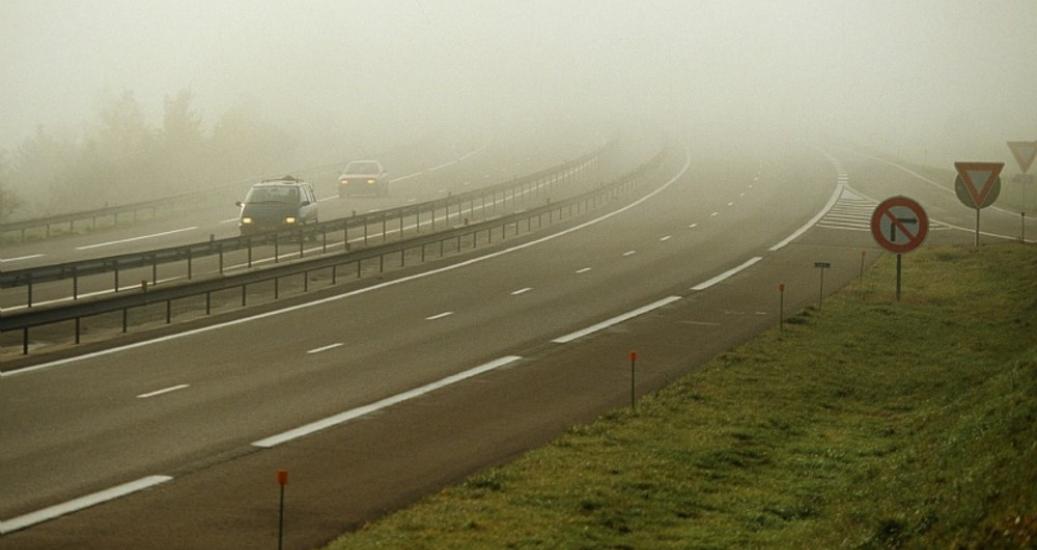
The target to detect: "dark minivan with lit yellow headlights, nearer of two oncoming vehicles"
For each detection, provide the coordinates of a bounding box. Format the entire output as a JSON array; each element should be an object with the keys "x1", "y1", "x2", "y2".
[{"x1": 235, "y1": 175, "x2": 317, "y2": 235}]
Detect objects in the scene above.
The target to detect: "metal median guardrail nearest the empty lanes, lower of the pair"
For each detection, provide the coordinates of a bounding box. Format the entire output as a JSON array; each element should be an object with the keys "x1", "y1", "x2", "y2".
[{"x1": 0, "y1": 145, "x2": 668, "y2": 355}]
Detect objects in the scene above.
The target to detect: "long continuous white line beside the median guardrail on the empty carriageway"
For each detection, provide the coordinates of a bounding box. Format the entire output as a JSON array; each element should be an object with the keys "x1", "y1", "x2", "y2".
[{"x1": 0, "y1": 149, "x2": 692, "y2": 378}]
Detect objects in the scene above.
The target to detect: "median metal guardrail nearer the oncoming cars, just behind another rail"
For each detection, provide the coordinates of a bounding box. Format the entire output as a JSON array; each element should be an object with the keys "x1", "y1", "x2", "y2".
[{"x1": 0, "y1": 143, "x2": 611, "y2": 300}]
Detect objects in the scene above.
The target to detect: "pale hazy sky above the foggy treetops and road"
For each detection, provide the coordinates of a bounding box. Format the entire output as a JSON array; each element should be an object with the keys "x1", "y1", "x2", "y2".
[{"x1": 0, "y1": 0, "x2": 1037, "y2": 161}]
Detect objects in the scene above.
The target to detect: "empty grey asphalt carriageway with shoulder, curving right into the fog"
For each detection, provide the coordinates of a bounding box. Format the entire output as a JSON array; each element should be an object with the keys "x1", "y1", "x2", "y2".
[{"x1": 0, "y1": 143, "x2": 1017, "y2": 548}]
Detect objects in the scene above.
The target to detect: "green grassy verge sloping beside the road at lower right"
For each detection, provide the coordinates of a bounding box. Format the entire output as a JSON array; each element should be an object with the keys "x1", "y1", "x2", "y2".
[{"x1": 328, "y1": 244, "x2": 1037, "y2": 549}]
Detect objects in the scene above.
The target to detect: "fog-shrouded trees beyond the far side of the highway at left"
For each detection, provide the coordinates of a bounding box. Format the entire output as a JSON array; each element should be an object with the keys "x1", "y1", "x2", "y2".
[{"x1": 0, "y1": 89, "x2": 296, "y2": 221}]
